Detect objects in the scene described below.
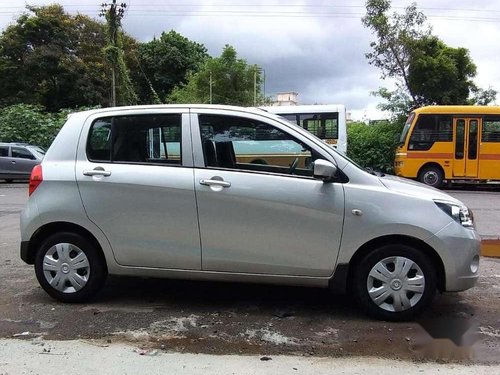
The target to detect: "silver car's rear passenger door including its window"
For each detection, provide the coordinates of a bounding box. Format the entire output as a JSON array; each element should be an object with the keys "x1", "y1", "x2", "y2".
[{"x1": 76, "y1": 110, "x2": 201, "y2": 270}]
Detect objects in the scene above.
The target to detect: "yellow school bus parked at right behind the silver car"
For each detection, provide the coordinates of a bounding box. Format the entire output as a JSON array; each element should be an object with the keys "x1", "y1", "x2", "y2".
[{"x1": 394, "y1": 106, "x2": 500, "y2": 187}]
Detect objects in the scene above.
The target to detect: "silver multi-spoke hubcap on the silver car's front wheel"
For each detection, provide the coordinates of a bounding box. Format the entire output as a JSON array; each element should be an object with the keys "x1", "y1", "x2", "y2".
[{"x1": 366, "y1": 256, "x2": 425, "y2": 312}]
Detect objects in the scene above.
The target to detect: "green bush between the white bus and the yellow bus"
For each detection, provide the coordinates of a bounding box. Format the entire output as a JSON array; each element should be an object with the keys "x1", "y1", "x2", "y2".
[{"x1": 347, "y1": 121, "x2": 403, "y2": 173}]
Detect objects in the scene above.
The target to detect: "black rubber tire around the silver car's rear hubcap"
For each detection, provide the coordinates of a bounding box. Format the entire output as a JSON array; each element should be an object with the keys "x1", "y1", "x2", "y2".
[{"x1": 35, "y1": 232, "x2": 108, "y2": 302}]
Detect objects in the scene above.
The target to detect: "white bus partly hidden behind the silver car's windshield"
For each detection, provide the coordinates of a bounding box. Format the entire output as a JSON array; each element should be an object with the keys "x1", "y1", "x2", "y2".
[{"x1": 261, "y1": 104, "x2": 347, "y2": 154}]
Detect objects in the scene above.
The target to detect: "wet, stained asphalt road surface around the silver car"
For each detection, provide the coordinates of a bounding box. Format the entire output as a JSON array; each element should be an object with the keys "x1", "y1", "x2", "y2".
[{"x1": 0, "y1": 183, "x2": 500, "y2": 363}]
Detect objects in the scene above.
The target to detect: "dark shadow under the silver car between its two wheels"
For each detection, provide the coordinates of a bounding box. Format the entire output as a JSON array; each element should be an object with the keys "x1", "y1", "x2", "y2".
[{"x1": 94, "y1": 276, "x2": 364, "y2": 319}]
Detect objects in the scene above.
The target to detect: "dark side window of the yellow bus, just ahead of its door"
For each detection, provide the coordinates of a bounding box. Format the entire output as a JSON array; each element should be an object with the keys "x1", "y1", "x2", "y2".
[{"x1": 408, "y1": 114, "x2": 453, "y2": 151}]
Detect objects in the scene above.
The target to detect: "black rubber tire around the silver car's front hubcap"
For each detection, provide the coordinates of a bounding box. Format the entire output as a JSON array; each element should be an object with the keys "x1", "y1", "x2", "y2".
[{"x1": 351, "y1": 244, "x2": 437, "y2": 321}]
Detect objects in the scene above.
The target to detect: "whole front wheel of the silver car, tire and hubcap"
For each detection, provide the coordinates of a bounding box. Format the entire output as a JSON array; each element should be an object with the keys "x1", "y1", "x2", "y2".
[{"x1": 352, "y1": 244, "x2": 436, "y2": 321}]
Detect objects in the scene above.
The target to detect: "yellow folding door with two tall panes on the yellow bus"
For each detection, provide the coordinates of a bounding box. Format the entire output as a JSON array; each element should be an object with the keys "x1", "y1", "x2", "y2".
[{"x1": 453, "y1": 118, "x2": 479, "y2": 177}]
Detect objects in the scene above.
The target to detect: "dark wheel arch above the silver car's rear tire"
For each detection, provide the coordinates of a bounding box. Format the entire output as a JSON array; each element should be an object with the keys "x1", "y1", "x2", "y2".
[{"x1": 27, "y1": 221, "x2": 108, "y2": 269}]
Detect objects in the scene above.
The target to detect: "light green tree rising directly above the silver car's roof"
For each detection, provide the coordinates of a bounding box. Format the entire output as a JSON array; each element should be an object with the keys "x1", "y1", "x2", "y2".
[{"x1": 168, "y1": 45, "x2": 265, "y2": 106}]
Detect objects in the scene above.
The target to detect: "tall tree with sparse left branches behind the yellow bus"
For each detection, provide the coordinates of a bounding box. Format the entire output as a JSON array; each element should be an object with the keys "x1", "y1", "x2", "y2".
[{"x1": 362, "y1": 0, "x2": 496, "y2": 118}]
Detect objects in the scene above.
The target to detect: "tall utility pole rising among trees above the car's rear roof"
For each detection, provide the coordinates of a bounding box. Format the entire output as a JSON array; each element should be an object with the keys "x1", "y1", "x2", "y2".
[{"x1": 99, "y1": 0, "x2": 127, "y2": 107}]
